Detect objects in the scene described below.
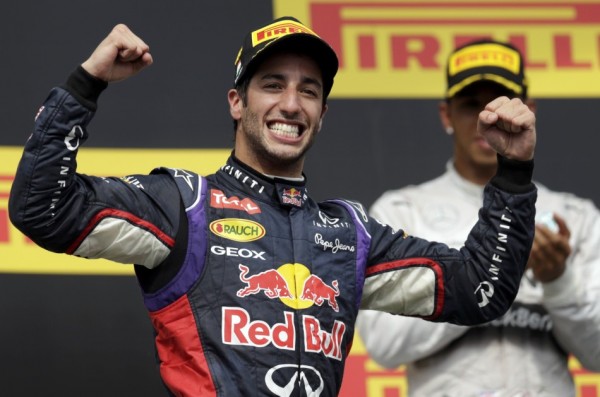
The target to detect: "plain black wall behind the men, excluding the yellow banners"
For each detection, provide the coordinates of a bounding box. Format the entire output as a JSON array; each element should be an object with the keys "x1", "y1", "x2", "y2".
[{"x1": 0, "y1": 0, "x2": 600, "y2": 396}]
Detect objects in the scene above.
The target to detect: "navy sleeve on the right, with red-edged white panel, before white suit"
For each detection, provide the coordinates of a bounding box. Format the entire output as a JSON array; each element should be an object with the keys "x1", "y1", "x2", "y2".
[{"x1": 361, "y1": 158, "x2": 536, "y2": 325}]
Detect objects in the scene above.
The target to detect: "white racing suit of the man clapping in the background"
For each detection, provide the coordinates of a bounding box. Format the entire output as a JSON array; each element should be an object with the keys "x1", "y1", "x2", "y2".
[{"x1": 357, "y1": 162, "x2": 600, "y2": 397}]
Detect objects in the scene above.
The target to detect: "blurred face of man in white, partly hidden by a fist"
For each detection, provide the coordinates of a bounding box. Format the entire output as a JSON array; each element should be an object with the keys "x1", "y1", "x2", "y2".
[{"x1": 440, "y1": 81, "x2": 533, "y2": 185}]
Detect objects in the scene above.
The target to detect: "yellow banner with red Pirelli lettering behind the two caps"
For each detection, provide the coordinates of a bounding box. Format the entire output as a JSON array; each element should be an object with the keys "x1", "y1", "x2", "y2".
[{"x1": 274, "y1": 0, "x2": 600, "y2": 99}]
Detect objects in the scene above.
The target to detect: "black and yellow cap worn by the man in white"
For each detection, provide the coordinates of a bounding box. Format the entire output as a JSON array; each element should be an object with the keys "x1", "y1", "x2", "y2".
[{"x1": 446, "y1": 39, "x2": 527, "y2": 98}]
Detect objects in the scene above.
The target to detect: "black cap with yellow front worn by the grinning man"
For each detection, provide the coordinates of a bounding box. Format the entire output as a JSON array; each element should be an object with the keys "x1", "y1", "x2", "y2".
[{"x1": 233, "y1": 17, "x2": 339, "y2": 97}]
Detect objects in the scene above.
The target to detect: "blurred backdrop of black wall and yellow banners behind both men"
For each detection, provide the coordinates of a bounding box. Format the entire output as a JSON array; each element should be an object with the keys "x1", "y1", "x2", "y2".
[{"x1": 0, "y1": 0, "x2": 600, "y2": 397}]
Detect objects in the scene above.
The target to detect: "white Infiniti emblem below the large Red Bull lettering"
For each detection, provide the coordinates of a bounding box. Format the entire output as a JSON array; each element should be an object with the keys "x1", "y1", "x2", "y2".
[{"x1": 265, "y1": 364, "x2": 324, "y2": 397}]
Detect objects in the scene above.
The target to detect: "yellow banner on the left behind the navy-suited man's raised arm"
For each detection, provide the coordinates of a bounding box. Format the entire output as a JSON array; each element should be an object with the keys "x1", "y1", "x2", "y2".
[{"x1": 0, "y1": 146, "x2": 231, "y2": 275}]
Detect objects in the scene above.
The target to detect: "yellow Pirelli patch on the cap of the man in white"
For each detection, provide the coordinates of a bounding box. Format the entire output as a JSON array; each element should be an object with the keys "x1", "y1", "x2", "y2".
[{"x1": 448, "y1": 44, "x2": 520, "y2": 76}]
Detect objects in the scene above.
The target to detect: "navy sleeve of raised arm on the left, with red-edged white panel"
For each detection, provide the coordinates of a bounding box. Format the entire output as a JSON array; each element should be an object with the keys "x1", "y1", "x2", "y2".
[{"x1": 9, "y1": 68, "x2": 180, "y2": 268}]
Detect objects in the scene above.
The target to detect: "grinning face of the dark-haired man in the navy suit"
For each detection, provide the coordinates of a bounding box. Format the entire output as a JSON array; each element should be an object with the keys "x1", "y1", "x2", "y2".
[{"x1": 228, "y1": 53, "x2": 327, "y2": 177}]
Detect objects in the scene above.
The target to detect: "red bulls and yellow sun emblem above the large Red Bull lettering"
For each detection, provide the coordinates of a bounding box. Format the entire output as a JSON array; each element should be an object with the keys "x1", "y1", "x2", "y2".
[{"x1": 237, "y1": 263, "x2": 340, "y2": 312}]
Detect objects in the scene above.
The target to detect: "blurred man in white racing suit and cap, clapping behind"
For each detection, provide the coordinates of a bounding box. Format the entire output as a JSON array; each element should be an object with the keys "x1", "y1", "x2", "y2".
[{"x1": 357, "y1": 40, "x2": 600, "y2": 397}]
